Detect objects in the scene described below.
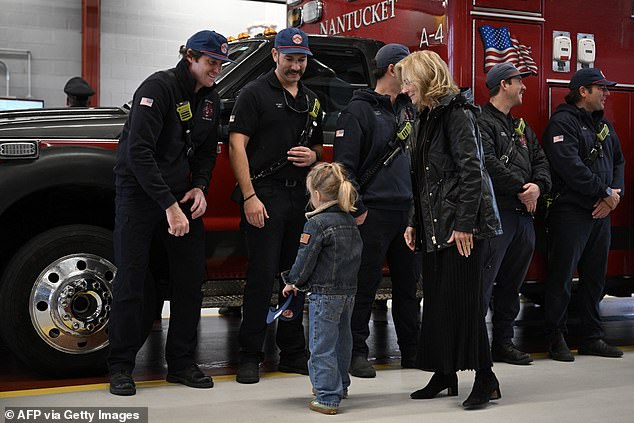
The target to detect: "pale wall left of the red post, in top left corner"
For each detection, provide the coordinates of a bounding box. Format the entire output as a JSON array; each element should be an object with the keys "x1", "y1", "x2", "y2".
[{"x1": 0, "y1": 0, "x2": 81, "y2": 106}]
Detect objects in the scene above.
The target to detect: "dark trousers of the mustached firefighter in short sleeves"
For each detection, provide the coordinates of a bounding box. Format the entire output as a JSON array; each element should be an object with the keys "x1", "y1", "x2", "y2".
[{"x1": 239, "y1": 179, "x2": 308, "y2": 363}]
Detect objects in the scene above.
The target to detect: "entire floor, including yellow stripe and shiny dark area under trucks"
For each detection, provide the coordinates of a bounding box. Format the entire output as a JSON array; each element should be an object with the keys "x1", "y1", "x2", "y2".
[{"x1": 0, "y1": 298, "x2": 634, "y2": 423}]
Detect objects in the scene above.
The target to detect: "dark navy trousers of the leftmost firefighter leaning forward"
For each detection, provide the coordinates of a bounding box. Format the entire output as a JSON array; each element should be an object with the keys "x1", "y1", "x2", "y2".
[{"x1": 108, "y1": 194, "x2": 205, "y2": 373}]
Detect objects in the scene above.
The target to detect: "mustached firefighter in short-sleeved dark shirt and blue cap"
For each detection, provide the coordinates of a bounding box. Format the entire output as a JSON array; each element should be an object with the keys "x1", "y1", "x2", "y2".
[{"x1": 229, "y1": 28, "x2": 323, "y2": 383}]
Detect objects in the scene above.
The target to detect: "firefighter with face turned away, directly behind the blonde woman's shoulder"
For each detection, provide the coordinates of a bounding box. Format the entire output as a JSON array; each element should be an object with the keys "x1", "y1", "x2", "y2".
[{"x1": 334, "y1": 44, "x2": 419, "y2": 378}]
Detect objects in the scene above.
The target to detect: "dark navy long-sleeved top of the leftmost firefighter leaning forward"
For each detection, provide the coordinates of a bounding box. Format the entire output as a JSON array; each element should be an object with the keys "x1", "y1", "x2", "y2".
[{"x1": 114, "y1": 60, "x2": 220, "y2": 210}]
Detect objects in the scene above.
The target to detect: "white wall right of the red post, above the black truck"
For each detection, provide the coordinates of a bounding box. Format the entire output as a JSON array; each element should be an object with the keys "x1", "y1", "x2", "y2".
[{"x1": 100, "y1": 0, "x2": 286, "y2": 106}]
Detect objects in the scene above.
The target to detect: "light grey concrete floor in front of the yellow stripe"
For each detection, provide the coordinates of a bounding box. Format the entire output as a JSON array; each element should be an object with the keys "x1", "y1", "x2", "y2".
[{"x1": 0, "y1": 349, "x2": 634, "y2": 423}]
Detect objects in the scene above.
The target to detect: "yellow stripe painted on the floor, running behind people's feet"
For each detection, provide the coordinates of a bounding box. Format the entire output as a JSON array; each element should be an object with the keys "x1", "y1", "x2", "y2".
[{"x1": 0, "y1": 345, "x2": 634, "y2": 398}]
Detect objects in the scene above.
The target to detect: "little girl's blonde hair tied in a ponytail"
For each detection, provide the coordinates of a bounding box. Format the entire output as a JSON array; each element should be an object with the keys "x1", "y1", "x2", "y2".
[{"x1": 306, "y1": 162, "x2": 358, "y2": 212}]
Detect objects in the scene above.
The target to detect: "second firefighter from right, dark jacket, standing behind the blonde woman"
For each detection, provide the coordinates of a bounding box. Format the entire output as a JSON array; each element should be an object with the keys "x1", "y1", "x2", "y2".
[{"x1": 478, "y1": 63, "x2": 551, "y2": 364}]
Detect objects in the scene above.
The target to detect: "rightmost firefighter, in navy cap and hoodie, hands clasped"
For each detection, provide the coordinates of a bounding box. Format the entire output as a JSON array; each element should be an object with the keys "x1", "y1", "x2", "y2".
[{"x1": 542, "y1": 68, "x2": 625, "y2": 361}]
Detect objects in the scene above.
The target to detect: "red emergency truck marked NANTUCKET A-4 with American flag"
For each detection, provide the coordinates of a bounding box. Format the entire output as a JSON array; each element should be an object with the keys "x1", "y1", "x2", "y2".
[{"x1": 287, "y1": 0, "x2": 634, "y2": 296}]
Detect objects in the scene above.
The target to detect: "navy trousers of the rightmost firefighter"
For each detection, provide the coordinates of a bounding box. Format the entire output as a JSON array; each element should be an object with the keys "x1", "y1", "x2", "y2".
[{"x1": 544, "y1": 209, "x2": 611, "y2": 340}]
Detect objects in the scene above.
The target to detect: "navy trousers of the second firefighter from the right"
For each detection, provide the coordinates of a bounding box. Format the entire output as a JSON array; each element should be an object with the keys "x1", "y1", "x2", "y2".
[{"x1": 482, "y1": 210, "x2": 535, "y2": 344}]
